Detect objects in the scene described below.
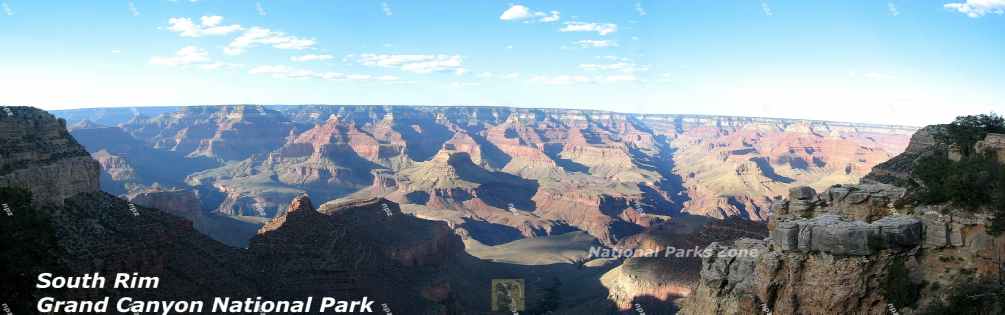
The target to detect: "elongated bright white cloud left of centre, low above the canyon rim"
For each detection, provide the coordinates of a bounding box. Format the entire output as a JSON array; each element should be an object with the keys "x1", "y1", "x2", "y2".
[{"x1": 358, "y1": 53, "x2": 466, "y2": 74}]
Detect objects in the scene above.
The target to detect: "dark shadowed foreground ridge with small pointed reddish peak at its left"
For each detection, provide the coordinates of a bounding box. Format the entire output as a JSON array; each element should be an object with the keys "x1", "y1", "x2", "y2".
[{"x1": 255, "y1": 195, "x2": 463, "y2": 311}]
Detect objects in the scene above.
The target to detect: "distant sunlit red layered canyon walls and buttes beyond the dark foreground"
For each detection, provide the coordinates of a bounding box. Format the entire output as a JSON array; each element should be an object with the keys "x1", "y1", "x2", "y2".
[{"x1": 53, "y1": 106, "x2": 916, "y2": 245}]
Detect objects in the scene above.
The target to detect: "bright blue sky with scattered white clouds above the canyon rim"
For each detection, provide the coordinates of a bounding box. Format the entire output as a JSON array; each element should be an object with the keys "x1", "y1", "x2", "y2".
[{"x1": 0, "y1": 0, "x2": 1005, "y2": 125}]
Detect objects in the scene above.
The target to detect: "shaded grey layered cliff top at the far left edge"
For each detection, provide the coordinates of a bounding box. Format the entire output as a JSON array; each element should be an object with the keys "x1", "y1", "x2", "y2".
[{"x1": 0, "y1": 107, "x2": 99, "y2": 206}]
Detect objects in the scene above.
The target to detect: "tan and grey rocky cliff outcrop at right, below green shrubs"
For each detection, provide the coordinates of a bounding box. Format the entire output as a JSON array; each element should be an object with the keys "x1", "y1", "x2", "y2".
[{"x1": 681, "y1": 127, "x2": 1005, "y2": 314}]
